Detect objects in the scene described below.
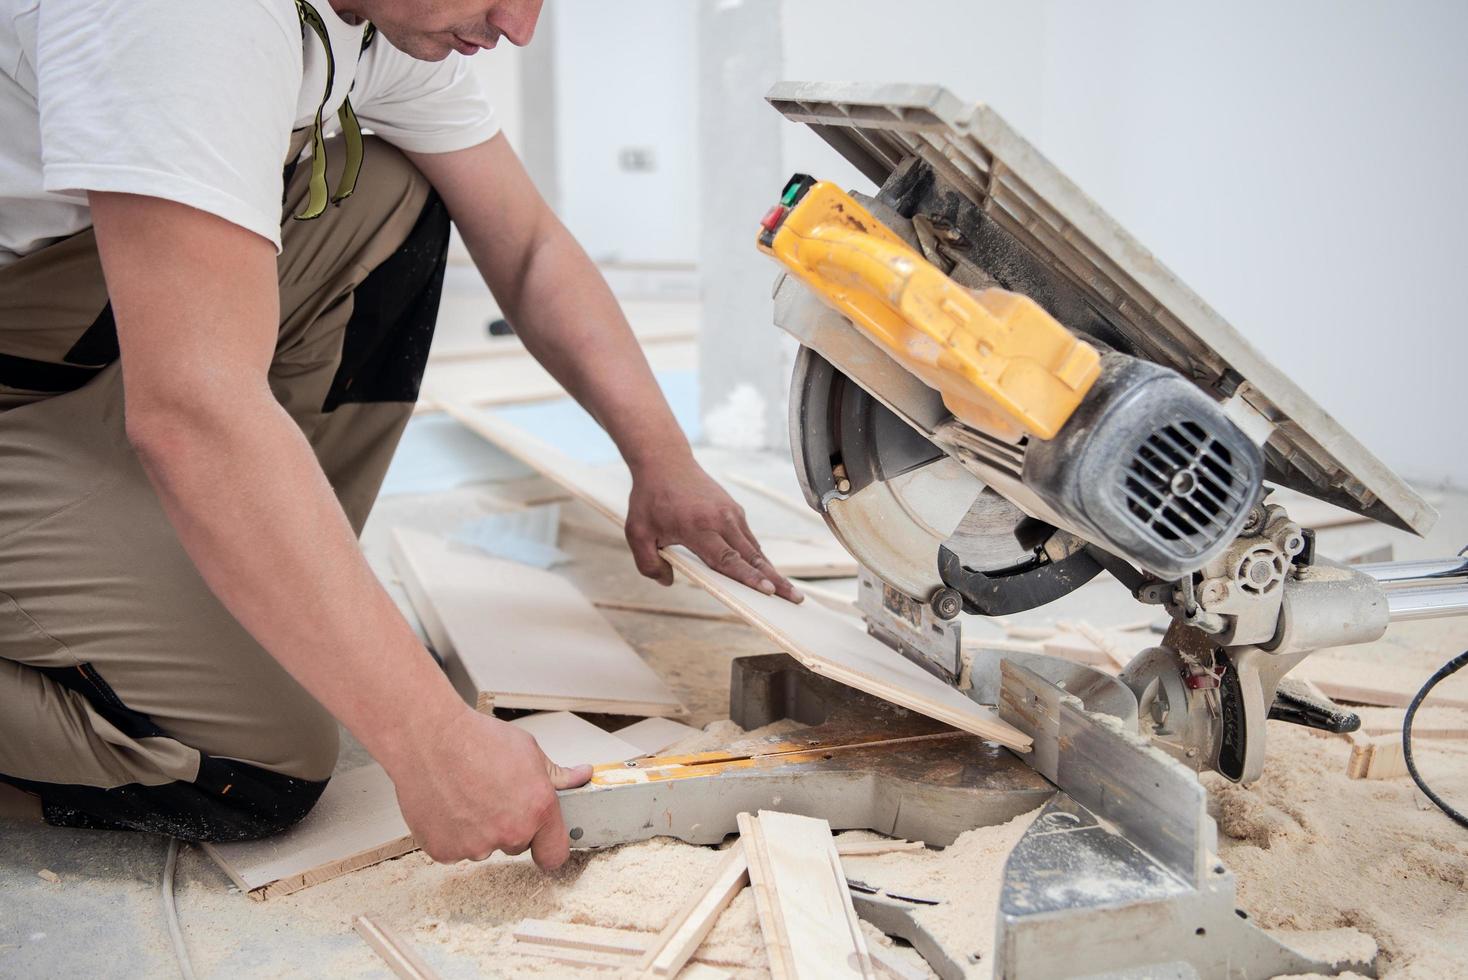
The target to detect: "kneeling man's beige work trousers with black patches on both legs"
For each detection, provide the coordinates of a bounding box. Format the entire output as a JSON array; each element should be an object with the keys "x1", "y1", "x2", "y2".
[{"x1": 0, "y1": 131, "x2": 448, "y2": 841}]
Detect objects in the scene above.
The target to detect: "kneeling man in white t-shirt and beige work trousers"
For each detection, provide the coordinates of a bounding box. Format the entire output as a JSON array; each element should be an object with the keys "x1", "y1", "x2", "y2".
[{"x1": 0, "y1": 0, "x2": 799, "y2": 867}]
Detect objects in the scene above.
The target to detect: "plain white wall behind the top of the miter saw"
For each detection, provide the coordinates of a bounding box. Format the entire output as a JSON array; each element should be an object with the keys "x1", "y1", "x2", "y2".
[{"x1": 784, "y1": 0, "x2": 1468, "y2": 486}]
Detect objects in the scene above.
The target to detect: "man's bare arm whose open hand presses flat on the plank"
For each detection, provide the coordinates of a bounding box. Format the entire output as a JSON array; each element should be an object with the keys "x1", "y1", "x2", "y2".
[{"x1": 408, "y1": 135, "x2": 800, "y2": 600}]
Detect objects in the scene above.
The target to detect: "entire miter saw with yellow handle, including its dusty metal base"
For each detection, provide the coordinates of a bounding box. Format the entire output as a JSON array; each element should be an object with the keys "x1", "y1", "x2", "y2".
[{"x1": 561, "y1": 84, "x2": 1468, "y2": 980}]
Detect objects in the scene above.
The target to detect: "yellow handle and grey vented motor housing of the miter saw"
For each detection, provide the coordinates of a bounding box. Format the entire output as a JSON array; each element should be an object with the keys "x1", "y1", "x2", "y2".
[{"x1": 759, "y1": 175, "x2": 1264, "y2": 589}]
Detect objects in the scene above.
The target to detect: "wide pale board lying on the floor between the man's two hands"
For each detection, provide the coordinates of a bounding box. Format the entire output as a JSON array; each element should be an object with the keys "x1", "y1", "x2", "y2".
[{"x1": 393, "y1": 528, "x2": 683, "y2": 714}]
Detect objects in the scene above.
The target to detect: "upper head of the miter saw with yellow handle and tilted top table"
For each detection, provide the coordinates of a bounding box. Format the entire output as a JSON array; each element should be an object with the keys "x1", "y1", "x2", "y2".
[{"x1": 757, "y1": 84, "x2": 1468, "y2": 798}]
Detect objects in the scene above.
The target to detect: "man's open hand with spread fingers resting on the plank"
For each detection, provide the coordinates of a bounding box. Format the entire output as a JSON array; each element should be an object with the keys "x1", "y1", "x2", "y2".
[{"x1": 627, "y1": 456, "x2": 804, "y2": 603}]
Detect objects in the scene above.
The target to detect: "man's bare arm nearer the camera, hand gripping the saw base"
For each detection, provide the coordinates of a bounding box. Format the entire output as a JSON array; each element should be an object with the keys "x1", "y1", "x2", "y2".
[{"x1": 91, "y1": 194, "x2": 586, "y2": 866}]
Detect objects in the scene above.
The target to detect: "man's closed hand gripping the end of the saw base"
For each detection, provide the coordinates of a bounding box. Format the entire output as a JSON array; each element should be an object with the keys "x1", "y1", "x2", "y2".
[{"x1": 388, "y1": 707, "x2": 592, "y2": 870}]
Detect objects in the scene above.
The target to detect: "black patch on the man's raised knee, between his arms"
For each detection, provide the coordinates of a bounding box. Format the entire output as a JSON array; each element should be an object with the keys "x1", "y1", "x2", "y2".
[{"x1": 321, "y1": 189, "x2": 449, "y2": 412}]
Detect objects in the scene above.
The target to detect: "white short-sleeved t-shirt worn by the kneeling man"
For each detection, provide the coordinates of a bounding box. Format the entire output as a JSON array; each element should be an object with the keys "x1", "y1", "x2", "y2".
[{"x1": 0, "y1": 0, "x2": 499, "y2": 267}]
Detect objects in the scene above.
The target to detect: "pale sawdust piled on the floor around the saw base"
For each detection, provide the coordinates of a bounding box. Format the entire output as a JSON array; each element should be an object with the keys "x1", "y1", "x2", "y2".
[{"x1": 171, "y1": 712, "x2": 1468, "y2": 980}]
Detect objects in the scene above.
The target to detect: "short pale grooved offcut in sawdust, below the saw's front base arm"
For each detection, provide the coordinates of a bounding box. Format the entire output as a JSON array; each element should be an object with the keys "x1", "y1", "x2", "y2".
[{"x1": 738, "y1": 810, "x2": 876, "y2": 980}]
